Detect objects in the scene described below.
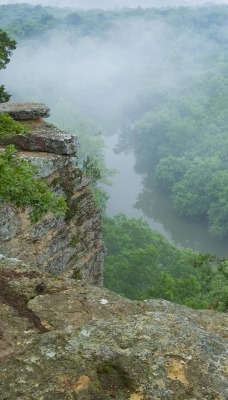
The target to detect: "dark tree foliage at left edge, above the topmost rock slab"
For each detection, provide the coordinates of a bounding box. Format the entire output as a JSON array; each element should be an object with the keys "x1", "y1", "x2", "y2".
[{"x1": 0, "y1": 29, "x2": 16, "y2": 103}]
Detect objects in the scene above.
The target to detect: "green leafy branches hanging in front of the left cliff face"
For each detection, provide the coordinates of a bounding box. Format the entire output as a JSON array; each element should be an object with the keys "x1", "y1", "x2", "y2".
[{"x1": 0, "y1": 145, "x2": 67, "y2": 222}]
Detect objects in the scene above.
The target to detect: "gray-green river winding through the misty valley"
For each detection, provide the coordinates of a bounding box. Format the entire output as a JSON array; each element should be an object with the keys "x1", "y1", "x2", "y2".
[{"x1": 104, "y1": 134, "x2": 228, "y2": 257}]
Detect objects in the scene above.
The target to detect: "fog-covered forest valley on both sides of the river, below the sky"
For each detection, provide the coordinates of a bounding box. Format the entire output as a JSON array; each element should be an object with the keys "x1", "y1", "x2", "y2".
[{"x1": 0, "y1": 4, "x2": 228, "y2": 311}]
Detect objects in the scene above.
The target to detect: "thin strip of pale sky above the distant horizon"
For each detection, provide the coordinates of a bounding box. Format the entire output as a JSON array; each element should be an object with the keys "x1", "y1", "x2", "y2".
[{"x1": 0, "y1": 0, "x2": 228, "y2": 9}]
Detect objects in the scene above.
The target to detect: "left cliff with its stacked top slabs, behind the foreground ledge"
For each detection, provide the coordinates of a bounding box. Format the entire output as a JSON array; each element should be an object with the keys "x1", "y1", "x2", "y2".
[{"x1": 0, "y1": 103, "x2": 104, "y2": 284}]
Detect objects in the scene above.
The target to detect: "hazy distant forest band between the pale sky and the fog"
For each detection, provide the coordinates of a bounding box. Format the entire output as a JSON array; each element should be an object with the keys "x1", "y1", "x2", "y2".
[{"x1": 0, "y1": 4, "x2": 228, "y2": 40}]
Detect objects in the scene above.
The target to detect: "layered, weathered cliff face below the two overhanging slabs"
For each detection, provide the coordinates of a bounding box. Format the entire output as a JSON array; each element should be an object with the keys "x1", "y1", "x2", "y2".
[{"x1": 0, "y1": 152, "x2": 104, "y2": 285}]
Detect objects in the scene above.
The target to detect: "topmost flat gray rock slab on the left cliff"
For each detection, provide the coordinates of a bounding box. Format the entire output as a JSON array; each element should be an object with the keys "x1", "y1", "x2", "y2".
[{"x1": 0, "y1": 102, "x2": 50, "y2": 121}]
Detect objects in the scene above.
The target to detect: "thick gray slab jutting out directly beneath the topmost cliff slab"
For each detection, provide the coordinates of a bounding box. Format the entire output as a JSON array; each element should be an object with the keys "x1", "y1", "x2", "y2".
[{"x1": 0, "y1": 120, "x2": 78, "y2": 155}]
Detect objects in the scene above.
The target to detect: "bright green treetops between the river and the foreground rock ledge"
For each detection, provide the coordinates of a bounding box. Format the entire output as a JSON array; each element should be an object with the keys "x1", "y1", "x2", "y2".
[{"x1": 104, "y1": 214, "x2": 209, "y2": 308}]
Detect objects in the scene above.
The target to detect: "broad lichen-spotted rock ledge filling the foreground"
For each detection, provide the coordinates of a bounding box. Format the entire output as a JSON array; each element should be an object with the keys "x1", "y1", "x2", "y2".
[{"x1": 0, "y1": 258, "x2": 228, "y2": 400}]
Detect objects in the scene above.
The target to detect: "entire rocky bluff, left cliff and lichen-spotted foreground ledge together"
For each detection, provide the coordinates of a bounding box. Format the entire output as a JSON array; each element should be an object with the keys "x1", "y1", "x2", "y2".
[{"x1": 0, "y1": 104, "x2": 228, "y2": 400}]
